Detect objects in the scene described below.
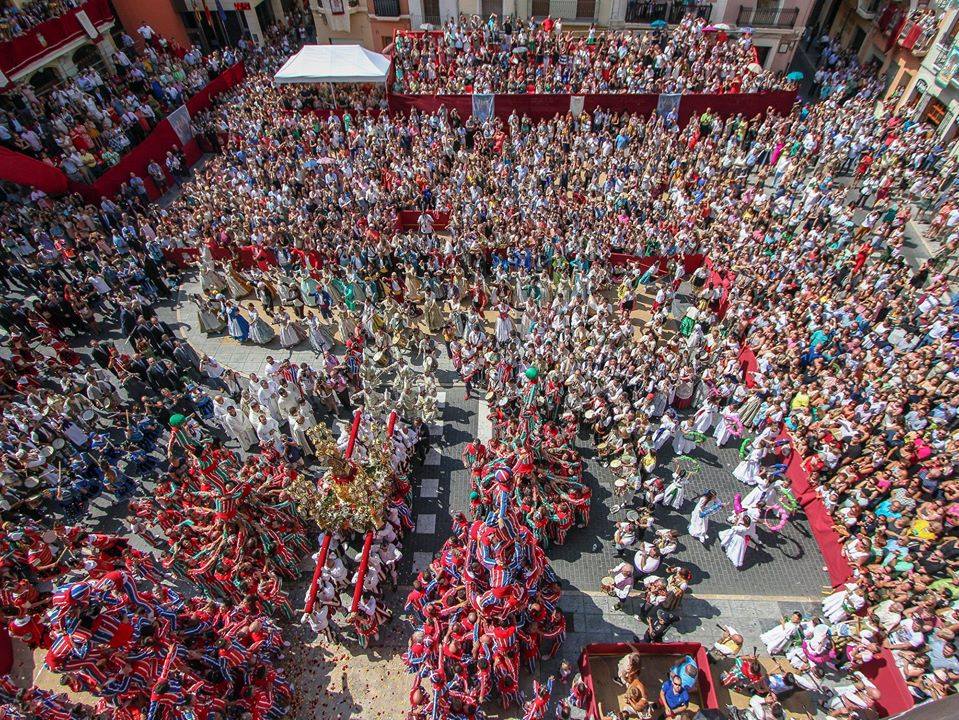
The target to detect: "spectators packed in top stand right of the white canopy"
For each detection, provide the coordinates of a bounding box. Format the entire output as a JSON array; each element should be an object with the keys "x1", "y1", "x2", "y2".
[{"x1": 392, "y1": 14, "x2": 794, "y2": 95}]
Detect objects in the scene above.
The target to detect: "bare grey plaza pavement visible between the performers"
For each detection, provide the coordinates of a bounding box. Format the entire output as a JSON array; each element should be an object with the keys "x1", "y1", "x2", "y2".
[{"x1": 146, "y1": 276, "x2": 827, "y2": 720}]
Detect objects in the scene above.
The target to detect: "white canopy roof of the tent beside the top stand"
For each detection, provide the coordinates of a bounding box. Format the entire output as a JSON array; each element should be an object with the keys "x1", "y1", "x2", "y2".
[{"x1": 273, "y1": 45, "x2": 390, "y2": 85}]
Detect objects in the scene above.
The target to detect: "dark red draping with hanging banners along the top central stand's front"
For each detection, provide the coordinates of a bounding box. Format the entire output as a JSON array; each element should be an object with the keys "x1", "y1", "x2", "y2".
[{"x1": 388, "y1": 90, "x2": 796, "y2": 125}]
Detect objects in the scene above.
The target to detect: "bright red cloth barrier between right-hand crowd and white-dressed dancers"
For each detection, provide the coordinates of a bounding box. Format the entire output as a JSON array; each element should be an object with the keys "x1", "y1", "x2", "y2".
[{"x1": 739, "y1": 345, "x2": 915, "y2": 717}]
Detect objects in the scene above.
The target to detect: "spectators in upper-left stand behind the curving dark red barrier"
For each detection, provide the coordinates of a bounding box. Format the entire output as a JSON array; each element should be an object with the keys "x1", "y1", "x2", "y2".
[{"x1": 0, "y1": 24, "x2": 237, "y2": 183}]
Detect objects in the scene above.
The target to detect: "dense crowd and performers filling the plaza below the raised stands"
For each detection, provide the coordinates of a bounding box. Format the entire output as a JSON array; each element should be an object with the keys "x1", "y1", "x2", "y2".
[{"x1": 0, "y1": 4, "x2": 959, "y2": 720}]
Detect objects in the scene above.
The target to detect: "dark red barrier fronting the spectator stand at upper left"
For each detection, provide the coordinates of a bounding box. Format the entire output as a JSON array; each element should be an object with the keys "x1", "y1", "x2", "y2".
[{"x1": 0, "y1": 63, "x2": 246, "y2": 202}]
